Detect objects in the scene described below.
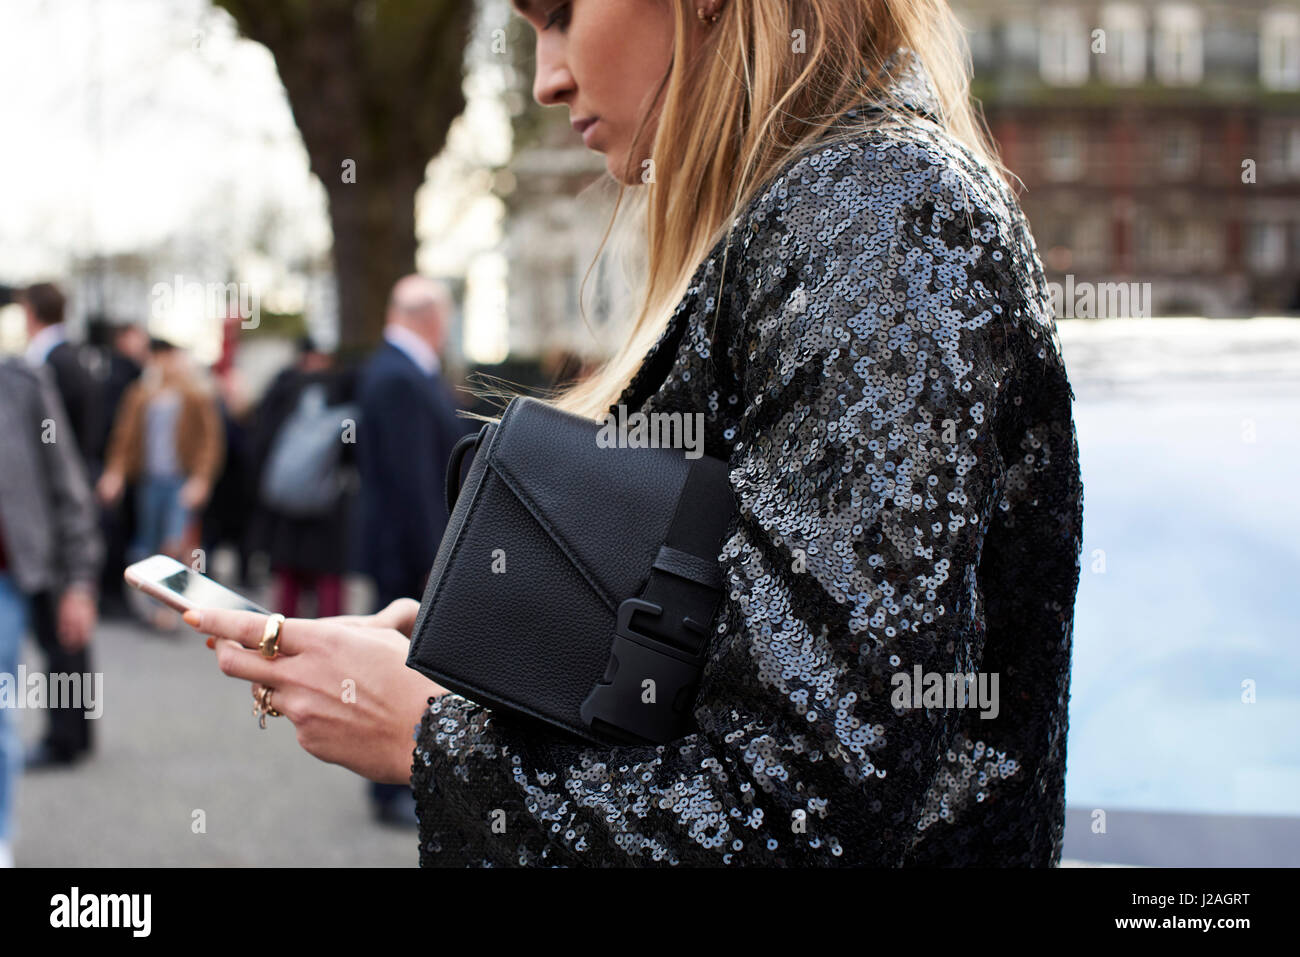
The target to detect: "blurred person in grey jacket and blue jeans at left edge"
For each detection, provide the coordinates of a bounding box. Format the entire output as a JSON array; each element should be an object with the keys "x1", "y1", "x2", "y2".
[{"x1": 0, "y1": 360, "x2": 103, "y2": 816}]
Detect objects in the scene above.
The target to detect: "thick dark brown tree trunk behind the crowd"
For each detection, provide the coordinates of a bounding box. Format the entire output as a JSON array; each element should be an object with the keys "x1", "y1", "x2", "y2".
[{"x1": 215, "y1": 0, "x2": 475, "y2": 354}]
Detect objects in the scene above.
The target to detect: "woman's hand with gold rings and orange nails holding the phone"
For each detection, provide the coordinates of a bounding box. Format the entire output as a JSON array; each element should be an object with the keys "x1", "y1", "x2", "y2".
[{"x1": 185, "y1": 599, "x2": 446, "y2": 784}]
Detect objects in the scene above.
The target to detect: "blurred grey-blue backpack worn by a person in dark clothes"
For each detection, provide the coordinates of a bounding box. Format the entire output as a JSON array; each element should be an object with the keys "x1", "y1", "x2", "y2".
[{"x1": 261, "y1": 382, "x2": 358, "y2": 519}]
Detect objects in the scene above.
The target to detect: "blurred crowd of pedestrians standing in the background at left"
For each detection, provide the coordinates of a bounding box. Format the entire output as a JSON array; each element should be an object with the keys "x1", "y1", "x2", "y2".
[{"x1": 0, "y1": 276, "x2": 543, "y2": 866}]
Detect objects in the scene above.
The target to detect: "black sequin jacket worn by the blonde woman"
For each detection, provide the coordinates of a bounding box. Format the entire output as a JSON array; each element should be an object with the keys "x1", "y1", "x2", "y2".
[{"x1": 411, "y1": 55, "x2": 1083, "y2": 866}]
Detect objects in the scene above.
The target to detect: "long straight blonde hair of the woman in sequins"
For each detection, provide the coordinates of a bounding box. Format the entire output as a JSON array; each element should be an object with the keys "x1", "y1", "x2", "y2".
[{"x1": 476, "y1": 0, "x2": 1006, "y2": 421}]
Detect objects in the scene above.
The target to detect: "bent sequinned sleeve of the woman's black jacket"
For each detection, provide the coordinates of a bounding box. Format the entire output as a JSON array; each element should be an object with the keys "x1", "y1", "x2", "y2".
[{"x1": 412, "y1": 136, "x2": 1008, "y2": 866}]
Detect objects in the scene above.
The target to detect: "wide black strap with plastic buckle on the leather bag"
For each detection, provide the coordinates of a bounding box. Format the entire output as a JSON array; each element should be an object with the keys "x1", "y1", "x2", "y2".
[{"x1": 580, "y1": 456, "x2": 733, "y2": 744}]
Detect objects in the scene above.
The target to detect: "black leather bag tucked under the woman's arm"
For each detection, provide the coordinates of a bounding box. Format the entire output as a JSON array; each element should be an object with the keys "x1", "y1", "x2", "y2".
[{"x1": 407, "y1": 397, "x2": 733, "y2": 744}]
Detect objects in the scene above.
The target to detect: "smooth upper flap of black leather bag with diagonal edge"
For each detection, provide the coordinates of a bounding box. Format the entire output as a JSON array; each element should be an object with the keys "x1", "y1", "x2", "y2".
[{"x1": 488, "y1": 397, "x2": 690, "y2": 611}]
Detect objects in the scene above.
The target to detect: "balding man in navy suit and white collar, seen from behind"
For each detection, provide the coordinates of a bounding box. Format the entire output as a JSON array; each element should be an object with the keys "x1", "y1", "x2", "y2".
[{"x1": 356, "y1": 276, "x2": 477, "y2": 824}]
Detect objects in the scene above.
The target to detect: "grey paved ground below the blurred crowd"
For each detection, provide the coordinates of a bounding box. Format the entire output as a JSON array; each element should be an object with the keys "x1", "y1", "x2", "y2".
[{"x1": 14, "y1": 613, "x2": 419, "y2": 867}]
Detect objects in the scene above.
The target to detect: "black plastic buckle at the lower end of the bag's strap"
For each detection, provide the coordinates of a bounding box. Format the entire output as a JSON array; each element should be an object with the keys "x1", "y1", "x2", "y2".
[{"x1": 579, "y1": 598, "x2": 703, "y2": 744}]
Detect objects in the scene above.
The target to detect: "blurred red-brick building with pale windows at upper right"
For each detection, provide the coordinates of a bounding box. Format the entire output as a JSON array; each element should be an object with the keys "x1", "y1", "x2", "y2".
[{"x1": 954, "y1": 0, "x2": 1300, "y2": 316}]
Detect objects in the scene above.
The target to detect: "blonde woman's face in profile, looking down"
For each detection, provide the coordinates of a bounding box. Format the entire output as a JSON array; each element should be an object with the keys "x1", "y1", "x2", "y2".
[{"x1": 514, "y1": 0, "x2": 672, "y2": 186}]
